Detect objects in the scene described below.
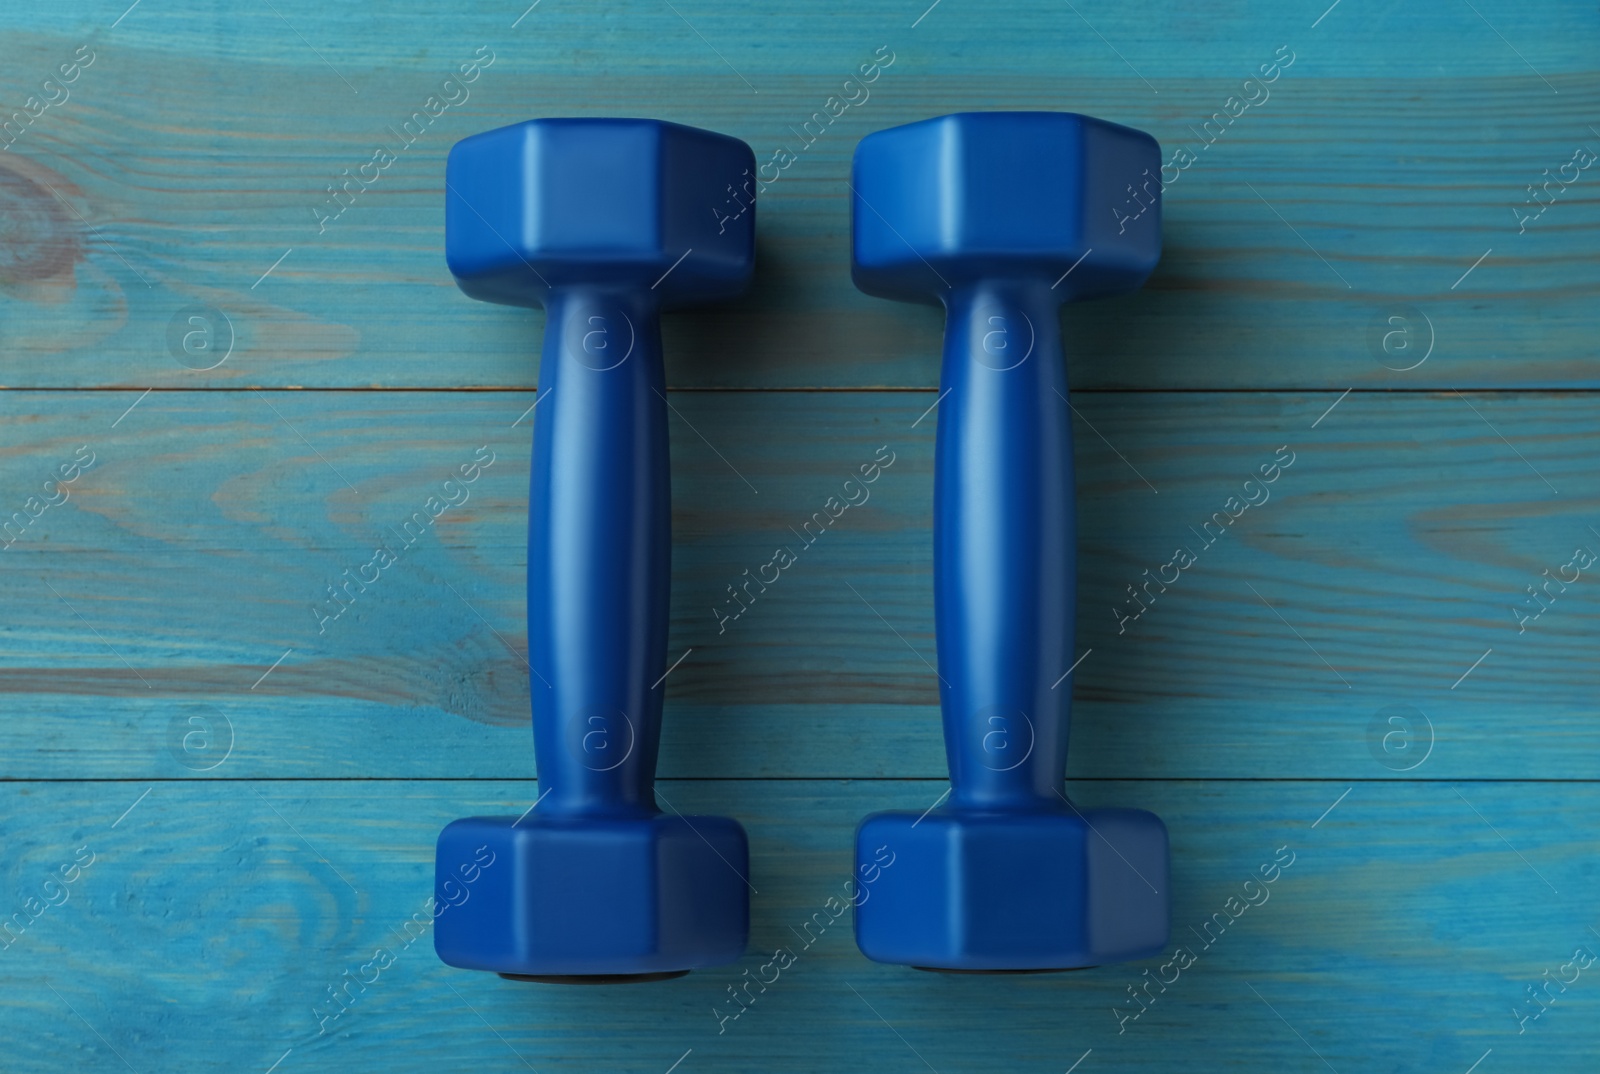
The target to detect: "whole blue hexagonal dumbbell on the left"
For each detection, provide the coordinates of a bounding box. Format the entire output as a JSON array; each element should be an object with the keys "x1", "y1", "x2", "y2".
[{"x1": 434, "y1": 118, "x2": 755, "y2": 983}]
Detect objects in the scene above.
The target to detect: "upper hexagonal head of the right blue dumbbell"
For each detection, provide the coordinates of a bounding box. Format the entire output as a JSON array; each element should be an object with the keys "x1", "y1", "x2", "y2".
[{"x1": 851, "y1": 112, "x2": 1162, "y2": 301}]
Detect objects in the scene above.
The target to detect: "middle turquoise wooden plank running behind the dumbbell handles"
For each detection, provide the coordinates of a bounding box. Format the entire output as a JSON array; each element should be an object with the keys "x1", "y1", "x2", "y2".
[{"x1": 0, "y1": 391, "x2": 1600, "y2": 779}]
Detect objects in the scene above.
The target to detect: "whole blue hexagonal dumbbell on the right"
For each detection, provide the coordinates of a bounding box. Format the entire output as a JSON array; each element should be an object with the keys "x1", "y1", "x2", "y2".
[{"x1": 851, "y1": 112, "x2": 1168, "y2": 970}]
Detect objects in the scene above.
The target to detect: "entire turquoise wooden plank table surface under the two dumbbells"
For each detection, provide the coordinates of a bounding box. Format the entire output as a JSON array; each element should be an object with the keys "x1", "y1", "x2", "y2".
[{"x1": 0, "y1": 0, "x2": 1600, "y2": 1074}]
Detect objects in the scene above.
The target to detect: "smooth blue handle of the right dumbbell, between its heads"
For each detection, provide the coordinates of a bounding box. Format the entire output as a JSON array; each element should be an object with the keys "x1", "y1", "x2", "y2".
[{"x1": 933, "y1": 282, "x2": 1077, "y2": 810}]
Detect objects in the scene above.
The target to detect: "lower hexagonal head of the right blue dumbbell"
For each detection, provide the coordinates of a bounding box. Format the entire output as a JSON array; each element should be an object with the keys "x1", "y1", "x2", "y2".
[{"x1": 856, "y1": 808, "x2": 1168, "y2": 972}]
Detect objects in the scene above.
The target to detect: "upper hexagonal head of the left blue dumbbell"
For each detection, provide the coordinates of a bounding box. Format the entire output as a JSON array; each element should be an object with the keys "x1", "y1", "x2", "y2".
[{"x1": 445, "y1": 118, "x2": 755, "y2": 306}]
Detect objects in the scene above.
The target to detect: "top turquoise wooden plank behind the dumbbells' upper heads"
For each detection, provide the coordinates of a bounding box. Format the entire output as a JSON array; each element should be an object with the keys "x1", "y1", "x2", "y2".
[{"x1": 0, "y1": 0, "x2": 1600, "y2": 391}]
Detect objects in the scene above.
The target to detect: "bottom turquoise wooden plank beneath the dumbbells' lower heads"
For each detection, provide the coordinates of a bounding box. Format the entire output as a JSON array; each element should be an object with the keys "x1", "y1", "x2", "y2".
[{"x1": 0, "y1": 781, "x2": 1600, "y2": 1074}]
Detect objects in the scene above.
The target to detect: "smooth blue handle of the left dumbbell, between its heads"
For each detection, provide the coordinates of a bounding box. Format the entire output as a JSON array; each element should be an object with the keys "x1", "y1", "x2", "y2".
[{"x1": 528, "y1": 288, "x2": 672, "y2": 816}]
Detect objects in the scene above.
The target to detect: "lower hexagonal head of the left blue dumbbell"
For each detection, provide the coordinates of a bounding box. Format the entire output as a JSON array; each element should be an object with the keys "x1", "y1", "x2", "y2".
[{"x1": 434, "y1": 813, "x2": 749, "y2": 980}]
